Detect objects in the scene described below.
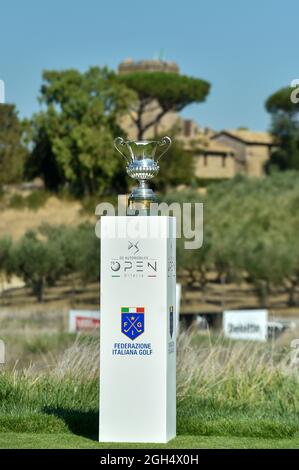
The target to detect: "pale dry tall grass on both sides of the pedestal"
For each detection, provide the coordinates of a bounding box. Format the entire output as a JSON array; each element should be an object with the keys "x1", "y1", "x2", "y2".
[{"x1": 11, "y1": 326, "x2": 299, "y2": 410}]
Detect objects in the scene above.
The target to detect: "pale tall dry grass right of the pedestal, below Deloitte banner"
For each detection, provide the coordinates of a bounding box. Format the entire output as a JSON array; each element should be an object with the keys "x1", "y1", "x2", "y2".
[{"x1": 177, "y1": 332, "x2": 299, "y2": 410}]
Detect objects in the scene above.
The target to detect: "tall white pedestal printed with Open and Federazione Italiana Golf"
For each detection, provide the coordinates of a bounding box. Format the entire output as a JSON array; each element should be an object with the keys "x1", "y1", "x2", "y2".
[{"x1": 99, "y1": 216, "x2": 176, "y2": 443}]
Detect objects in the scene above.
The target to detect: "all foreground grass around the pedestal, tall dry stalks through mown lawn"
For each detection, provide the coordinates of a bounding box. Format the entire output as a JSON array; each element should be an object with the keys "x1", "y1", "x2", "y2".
[{"x1": 0, "y1": 336, "x2": 299, "y2": 448}]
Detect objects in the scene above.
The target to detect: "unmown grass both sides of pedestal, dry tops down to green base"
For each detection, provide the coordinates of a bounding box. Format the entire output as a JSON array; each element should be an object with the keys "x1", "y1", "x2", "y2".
[{"x1": 0, "y1": 333, "x2": 299, "y2": 437}]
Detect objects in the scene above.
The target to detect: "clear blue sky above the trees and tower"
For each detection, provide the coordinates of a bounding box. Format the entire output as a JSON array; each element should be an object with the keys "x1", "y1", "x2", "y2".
[{"x1": 0, "y1": 0, "x2": 299, "y2": 130}]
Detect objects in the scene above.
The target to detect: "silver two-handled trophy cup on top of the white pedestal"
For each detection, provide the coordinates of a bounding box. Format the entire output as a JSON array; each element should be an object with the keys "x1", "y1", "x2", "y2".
[{"x1": 114, "y1": 136, "x2": 171, "y2": 215}]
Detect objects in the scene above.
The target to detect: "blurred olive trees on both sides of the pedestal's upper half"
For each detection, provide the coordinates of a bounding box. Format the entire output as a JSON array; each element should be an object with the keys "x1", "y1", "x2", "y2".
[{"x1": 0, "y1": 172, "x2": 299, "y2": 307}]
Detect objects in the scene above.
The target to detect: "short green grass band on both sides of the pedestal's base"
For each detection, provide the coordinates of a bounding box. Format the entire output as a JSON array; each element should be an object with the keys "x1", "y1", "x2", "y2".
[{"x1": 0, "y1": 386, "x2": 299, "y2": 442}]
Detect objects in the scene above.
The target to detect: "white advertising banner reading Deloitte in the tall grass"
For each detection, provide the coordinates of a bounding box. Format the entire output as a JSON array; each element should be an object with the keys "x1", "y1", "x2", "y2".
[{"x1": 223, "y1": 310, "x2": 268, "y2": 341}]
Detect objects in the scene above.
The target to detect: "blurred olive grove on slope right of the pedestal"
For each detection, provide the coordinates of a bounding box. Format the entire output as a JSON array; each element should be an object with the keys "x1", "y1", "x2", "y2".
[{"x1": 172, "y1": 171, "x2": 299, "y2": 307}]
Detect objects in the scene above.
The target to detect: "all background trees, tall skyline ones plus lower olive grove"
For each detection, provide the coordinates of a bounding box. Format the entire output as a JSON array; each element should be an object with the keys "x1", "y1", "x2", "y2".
[{"x1": 0, "y1": 67, "x2": 299, "y2": 305}]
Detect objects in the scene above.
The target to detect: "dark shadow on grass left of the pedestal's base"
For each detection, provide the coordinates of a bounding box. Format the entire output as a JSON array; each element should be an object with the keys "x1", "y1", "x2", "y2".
[{"x1": 43, "y1": 407, "x2": 99, "y2": 441}]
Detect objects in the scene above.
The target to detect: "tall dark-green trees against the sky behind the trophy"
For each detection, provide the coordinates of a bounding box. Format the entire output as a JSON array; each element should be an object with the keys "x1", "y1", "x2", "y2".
[{"x1": 0, "y1": 67, "x2": 299, "y2": 197}]
